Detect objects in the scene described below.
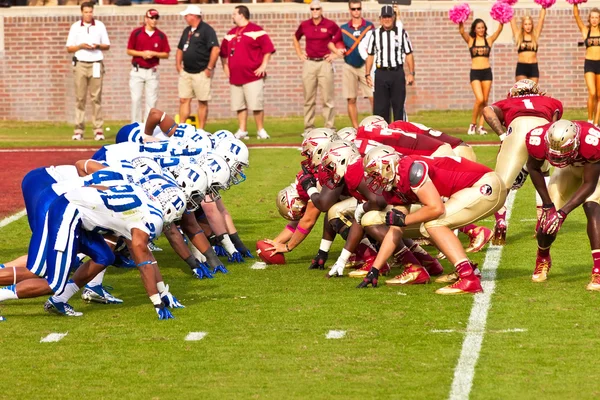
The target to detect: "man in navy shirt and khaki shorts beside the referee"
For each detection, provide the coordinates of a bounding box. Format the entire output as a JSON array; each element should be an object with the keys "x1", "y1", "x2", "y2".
[{"x1": 340, "y1": 0, "x2": 374, "y2": 128}]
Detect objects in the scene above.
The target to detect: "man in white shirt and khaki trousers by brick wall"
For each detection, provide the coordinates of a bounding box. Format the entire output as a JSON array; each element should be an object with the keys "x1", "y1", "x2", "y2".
[{"x1": 67, "y1": 2, "x2": 110, "y2": 140}]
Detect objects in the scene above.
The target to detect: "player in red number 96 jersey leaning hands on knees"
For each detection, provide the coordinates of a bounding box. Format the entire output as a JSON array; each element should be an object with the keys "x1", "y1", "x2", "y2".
[{"x1": 526, "y1": 120, "x2": 600, "y2": 290}]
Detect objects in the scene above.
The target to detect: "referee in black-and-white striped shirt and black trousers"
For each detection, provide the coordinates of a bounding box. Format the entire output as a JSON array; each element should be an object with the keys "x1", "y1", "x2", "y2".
[{"x1": 365, "y1": 5, "x2": 415, "y2": 123}]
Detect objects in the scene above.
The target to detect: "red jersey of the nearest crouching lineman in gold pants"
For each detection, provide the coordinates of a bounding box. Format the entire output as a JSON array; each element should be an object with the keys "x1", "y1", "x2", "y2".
[{"x1": 384, "y1": 156, "x2": 492, "y2": 205}]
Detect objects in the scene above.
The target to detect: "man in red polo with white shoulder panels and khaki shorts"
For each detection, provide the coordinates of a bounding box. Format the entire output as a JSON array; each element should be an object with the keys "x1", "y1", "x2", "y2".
[{"x1": 220, "y1": 6, "x2": 275, "y2": 139}]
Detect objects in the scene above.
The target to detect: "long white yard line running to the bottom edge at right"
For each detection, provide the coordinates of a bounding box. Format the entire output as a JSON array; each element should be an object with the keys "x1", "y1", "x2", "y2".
[{"x1": 449, "y1": 190, "x2": 516, "y2": 400}]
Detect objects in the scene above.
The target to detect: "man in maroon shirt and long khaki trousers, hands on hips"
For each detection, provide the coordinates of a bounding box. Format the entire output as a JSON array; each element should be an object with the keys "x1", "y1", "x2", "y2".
[{"x1": 294, "y1": 0, "x2": 343, "y2": 133}]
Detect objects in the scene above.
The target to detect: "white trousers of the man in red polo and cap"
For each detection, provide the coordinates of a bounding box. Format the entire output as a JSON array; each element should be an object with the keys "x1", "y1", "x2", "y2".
[{"x1": 129, "y1": 68, "x2": 159, "y2": 122}]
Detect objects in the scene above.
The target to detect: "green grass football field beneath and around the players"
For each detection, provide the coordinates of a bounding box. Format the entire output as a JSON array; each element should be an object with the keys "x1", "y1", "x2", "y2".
[{"x1": 0, "y1": 110, "x2": 600, "y2": 399}]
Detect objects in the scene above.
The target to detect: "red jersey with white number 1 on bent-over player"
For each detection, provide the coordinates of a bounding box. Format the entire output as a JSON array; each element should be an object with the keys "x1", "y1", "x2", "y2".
[{"x1": 493, "y1": 95, "x2": 563, "y2": 127}]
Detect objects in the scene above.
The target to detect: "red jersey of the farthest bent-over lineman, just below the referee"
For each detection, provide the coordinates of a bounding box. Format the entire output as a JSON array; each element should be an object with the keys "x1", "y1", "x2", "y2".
[{"x1": 354, "y1": 125, "x2": 444, "y2": 156}]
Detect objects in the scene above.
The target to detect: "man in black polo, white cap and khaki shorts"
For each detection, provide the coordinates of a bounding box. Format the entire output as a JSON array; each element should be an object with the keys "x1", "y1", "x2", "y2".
[{"x1": 175, "y1": 5, "x2": 219, "y2": 129}]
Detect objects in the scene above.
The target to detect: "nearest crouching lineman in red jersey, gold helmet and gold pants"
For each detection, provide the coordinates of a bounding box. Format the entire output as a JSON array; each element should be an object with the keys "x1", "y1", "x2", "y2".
[{"x1": 358, "y1": 146, "x2": 506, "y2": 294}]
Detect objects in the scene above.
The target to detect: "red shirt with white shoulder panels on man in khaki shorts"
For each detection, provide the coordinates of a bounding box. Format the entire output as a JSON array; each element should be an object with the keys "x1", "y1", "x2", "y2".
[{"x1": 220, "y1": 22, "x2": 275, "y2": 85}]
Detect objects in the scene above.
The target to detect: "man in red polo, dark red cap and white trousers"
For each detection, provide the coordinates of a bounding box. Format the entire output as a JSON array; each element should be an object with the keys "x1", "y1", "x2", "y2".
[{"x1": 127, "y1": 8, "x2": 171, "y2": 122}]
